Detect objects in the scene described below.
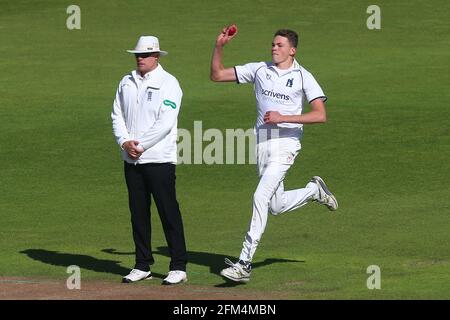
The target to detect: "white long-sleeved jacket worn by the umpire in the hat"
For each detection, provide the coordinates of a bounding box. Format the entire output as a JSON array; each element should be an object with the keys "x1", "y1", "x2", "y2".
[{"x1": 111, "y1": 65, "x2": 183, "y2": 164}]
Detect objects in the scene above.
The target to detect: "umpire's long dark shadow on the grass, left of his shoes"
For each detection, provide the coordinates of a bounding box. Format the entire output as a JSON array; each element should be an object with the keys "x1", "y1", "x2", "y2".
[{"x1": 20, "y1": 249, "x2": 165, "y2": 279}]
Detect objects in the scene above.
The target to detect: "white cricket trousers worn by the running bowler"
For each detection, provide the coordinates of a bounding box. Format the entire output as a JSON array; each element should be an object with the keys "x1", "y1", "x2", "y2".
[{"x1": 239, "y1": 138, "x2": 318, "y2": 261}]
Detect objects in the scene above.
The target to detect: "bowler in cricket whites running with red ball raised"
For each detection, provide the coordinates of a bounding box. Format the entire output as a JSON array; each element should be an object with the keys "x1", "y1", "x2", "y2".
[{"x1": 210, "y1": 25, "x2": 338, "y2": 282}]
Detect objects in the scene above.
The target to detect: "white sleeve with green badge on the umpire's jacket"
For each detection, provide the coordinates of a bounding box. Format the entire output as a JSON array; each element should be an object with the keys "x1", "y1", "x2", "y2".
[{"x1": 137, "y1": 79, "x2": 183, "y2": 150}]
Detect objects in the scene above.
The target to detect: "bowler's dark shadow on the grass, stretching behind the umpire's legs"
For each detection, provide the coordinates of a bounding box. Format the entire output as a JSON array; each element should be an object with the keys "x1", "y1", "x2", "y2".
[{"x1": 102, "y1": 247, "x2": 305, "y2": 288}]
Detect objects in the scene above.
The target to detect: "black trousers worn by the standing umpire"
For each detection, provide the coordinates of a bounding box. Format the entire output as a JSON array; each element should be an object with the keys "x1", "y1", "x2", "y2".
[{"x1": 124, "y1": 162, "x2": 187, "y2": 271}]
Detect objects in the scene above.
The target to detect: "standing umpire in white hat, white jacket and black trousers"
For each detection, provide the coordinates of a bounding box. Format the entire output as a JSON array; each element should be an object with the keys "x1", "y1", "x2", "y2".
[{"x1": 111, "y1": 36, "x2": 187, "y2": 284}]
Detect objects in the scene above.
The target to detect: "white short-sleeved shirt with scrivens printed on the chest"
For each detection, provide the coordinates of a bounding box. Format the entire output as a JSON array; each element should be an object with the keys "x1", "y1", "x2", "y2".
[{"x1": 235, "y1": 59, "x2": 327, "y2": 138}]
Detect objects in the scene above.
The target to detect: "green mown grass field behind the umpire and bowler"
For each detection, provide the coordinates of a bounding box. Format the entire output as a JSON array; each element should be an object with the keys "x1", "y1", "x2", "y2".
[{"x1": 0, "y1": 0, "x2": 450, "y2": 299}]
